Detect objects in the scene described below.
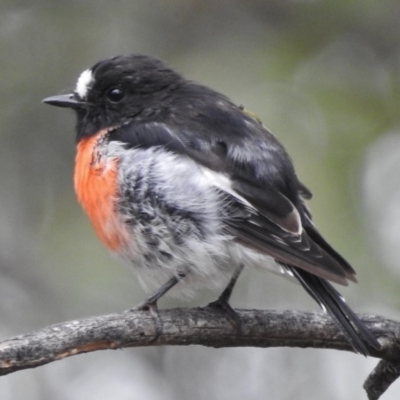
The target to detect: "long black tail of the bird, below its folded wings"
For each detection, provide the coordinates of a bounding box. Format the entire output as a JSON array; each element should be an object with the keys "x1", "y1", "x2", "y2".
[{"x1": 289, "y1": 267, "x2": 381, "y2": 356}]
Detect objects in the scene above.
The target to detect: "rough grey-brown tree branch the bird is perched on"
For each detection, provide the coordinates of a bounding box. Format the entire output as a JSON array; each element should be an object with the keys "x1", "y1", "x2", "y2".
[{"x1": 0, "y1": 307, "x2": 400, "y2": 400}]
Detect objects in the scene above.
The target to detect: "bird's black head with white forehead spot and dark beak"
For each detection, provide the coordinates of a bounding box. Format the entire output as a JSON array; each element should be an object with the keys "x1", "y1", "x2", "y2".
[{"x1": 43, "y1": 54, "x2": 184, "y2": 139}]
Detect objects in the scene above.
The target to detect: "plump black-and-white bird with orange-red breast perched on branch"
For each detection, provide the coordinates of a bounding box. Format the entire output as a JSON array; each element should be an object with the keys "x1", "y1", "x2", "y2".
[{"x1": 43, "y1": 54, "x2": 380, "y2": 356}]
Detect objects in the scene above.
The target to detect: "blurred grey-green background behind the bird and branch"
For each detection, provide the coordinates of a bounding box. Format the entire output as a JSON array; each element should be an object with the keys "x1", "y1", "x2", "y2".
[{"x1": 0, "y1": 0, "x2": 400, "y2": 400}]
